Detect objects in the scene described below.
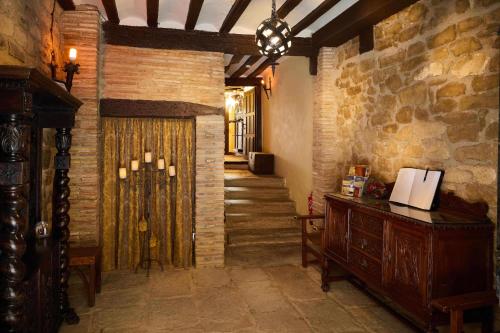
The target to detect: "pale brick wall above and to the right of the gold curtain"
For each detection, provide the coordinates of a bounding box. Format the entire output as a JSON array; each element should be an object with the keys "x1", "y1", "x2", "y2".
[{"x1": 103, "y1": 45, "x2": 224, "y2": 267}]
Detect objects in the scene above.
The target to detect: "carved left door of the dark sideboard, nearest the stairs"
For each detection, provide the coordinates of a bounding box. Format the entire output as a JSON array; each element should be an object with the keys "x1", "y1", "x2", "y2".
[{"x1": 324, "y1": 198, "x2": 349, "y2": 263}]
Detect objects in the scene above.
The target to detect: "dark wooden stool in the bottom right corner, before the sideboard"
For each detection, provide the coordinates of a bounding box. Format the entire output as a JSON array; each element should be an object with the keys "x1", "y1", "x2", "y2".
[{"x1": 431, "y1": 290, "x2": 498, "y2": 333}]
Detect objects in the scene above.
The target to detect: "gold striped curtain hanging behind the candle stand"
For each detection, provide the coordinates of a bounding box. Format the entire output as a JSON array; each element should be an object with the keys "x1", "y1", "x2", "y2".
[{"x1": 102, "y1": 118, "x2": 194, "y2": 270}]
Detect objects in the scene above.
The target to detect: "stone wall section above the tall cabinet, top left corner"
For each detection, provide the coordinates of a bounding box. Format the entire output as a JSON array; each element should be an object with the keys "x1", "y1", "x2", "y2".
[{"x1": 0, "y1": 0, "x2": 63, "y2": 78}]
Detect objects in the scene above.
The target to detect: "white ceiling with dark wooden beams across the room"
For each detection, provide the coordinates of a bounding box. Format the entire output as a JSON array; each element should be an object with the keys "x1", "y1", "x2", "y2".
[{"x1": 64, "y1": 0, "x2": 417, "y2": 78}]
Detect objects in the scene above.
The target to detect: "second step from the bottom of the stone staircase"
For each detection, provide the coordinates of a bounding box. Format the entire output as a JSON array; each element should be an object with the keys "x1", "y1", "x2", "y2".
[{"x1": 226, "y1": 228, "x2": 301, "y2": 247}]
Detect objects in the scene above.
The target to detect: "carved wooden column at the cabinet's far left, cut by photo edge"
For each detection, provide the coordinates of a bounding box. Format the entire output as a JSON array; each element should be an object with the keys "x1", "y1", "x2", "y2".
[{"x1": 0, "y1": 113, "x2": 31, "y2": 332}]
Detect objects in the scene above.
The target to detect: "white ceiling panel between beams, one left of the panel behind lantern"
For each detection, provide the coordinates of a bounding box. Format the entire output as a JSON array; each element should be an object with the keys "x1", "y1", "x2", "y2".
[{"x1": 194, "y1": 0, "x2": 235, "y2": 31}]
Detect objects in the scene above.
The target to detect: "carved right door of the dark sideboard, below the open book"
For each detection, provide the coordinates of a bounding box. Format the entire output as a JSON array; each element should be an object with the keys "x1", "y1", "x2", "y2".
[{"x1": 382, "y1": 220, "x2": 430, "y2": 309}]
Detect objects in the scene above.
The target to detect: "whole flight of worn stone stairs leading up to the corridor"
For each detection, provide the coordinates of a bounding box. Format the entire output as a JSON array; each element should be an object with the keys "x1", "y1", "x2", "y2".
[{"x1": 224, "y1": 169, "x2": 300, "y2": 266}]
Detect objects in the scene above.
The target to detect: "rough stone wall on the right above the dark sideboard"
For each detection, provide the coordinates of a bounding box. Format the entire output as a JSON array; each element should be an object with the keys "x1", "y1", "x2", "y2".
[{"x1": 313, "y1": 0, "x2": 500, "y2": 220}]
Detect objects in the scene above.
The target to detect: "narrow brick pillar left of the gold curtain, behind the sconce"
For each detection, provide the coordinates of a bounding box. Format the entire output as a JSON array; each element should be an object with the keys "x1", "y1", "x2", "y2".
[{"x1": 62, "y1": 6, "x2": 101, "y2": 241}]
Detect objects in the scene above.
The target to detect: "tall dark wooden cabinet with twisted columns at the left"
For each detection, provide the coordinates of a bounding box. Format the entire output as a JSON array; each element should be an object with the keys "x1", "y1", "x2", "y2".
[{"x1": 0, "y1": 66, "x2": 81, "y2": 333}]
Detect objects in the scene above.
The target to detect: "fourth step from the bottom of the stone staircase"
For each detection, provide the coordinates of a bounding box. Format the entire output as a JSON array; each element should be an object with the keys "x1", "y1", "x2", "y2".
[{"x1": 224, "y1": 199, "x2": 295, "y2": 214}]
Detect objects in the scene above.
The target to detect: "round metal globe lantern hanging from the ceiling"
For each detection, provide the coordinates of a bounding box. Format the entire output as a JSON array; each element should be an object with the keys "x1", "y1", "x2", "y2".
[{"x1": 255, "y1": 0, "x2": 292, "y2": 76}]
